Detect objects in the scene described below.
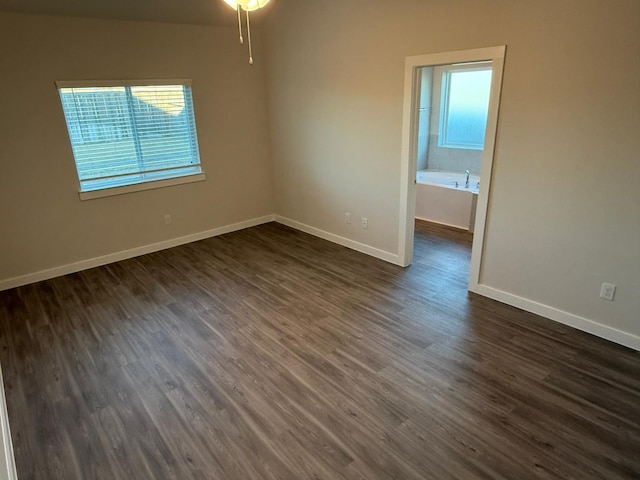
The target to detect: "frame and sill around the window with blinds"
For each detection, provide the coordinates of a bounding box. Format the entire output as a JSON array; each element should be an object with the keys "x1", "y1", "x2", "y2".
[{"x1": 55, "y1": 78, "x2": 206, "y2": 200}]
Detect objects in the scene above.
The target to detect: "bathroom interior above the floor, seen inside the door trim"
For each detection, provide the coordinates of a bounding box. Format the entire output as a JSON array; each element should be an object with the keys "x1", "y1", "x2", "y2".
[{"x1": 415, "y1": 61, "x2": 493, "y2": 233}]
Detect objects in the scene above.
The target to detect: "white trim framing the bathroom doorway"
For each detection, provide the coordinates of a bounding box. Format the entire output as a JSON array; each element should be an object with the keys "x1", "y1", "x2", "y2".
[{"x1": 398, "y1": 45, "x2": 507, "y2": 291}]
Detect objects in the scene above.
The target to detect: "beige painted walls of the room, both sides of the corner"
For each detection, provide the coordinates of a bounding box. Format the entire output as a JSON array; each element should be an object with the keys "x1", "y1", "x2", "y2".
[{"x1": 0, "y1": 0, "x2": 640, "y2": 344}]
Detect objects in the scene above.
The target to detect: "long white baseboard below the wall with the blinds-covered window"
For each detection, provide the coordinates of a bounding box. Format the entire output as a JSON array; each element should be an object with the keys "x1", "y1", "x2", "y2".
[{"x1": 0, "y1": 215, "x2": 274, "y2": 292}]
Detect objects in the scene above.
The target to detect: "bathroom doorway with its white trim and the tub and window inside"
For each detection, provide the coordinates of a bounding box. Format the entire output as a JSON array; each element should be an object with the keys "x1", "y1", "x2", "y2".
[{"x1": 399, "y1": 46, "x2": 506, "y2": 291}]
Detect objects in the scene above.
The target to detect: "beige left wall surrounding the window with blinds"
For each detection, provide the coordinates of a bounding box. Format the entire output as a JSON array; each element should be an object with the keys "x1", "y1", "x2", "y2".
[{"x1": 0, "y1": 14, "x2": 274, "y2": 281}]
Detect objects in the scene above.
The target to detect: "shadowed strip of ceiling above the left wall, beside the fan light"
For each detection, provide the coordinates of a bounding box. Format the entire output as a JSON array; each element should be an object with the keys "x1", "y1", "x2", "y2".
[{"x1": 0, "y1": 0, "x2": 273, "y2": 26}]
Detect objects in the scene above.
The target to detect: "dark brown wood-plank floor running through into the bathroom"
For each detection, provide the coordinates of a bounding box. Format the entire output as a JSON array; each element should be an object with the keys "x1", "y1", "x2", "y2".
[{"x1": 0, "y1": 223, "x2": 640, "y2": 480}]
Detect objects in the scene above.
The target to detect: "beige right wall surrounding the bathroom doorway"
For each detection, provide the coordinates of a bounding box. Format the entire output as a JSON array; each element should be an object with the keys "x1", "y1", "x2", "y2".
[{"x1": 266, "y1": 0, "x2": 640, "y2": 338}]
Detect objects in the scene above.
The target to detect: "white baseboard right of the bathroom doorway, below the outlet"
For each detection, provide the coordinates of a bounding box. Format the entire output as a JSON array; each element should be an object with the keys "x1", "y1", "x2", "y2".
[{"x1": 469, "y1": 285, "x2": 640, "y2": 351}]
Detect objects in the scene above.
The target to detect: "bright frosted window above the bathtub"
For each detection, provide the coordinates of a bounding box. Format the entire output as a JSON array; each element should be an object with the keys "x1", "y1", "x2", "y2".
[{"x1": 438, "y1": 66, "x2": 491, "y2": 150}]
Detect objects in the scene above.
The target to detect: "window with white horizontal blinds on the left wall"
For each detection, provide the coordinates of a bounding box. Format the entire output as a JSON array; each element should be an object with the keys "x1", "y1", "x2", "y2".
[{"x1": 56, "y1": 81, "x2": 202, "y2": 192}]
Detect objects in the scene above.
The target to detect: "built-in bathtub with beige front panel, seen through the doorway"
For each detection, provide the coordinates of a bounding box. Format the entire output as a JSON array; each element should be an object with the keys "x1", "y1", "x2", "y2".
[{"x1": 416, "y1": 170, "x2": 480, "y2": 232}]
